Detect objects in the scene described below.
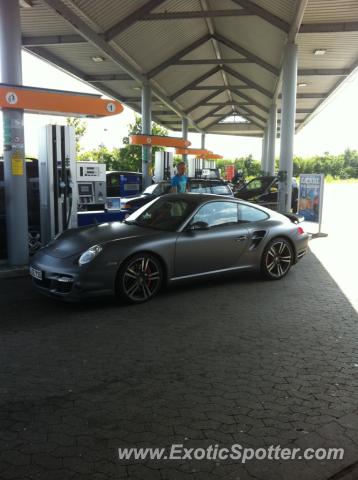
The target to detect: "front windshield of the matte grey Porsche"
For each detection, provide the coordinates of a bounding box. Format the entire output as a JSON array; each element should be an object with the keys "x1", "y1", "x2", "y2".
[{"x1": 125, "y1": 196, "x2": 197, "y2": 232}]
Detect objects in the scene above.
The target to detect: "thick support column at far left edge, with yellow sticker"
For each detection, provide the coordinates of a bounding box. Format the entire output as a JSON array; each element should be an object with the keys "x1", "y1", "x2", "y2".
[{"x1": 0, "y1": 0, "x2": 28, "y2": 265}]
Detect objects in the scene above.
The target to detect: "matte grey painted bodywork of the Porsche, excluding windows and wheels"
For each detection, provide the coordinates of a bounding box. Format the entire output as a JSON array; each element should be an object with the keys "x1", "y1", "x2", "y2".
[{"x1": 32, "y1": 193, "x2": 308, "y2": 298}]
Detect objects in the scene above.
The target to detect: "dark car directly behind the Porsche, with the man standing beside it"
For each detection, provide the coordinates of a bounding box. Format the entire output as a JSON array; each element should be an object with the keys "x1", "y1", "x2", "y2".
[{"x1": 121, "y1": 178, "x2": 233, "y2": 215}]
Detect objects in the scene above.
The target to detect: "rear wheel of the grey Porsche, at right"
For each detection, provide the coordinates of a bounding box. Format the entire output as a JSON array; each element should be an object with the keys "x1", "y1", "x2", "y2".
[{"x1": 261, "y1": 238, "x2": 293, "y2": 280}]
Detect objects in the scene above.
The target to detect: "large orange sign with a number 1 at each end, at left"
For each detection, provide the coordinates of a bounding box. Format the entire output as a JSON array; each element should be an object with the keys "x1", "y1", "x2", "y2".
[{"x1": 0, "y1": 84, "x2": 123, "y2": 117}]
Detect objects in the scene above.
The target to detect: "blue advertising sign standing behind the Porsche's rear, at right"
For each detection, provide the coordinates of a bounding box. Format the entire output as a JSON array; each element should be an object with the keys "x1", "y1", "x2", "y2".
[{"x1": 298, "y1": 174, "x2": 324, "y2": 224}]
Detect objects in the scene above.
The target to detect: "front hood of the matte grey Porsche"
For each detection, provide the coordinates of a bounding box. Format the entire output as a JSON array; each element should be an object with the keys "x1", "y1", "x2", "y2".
[{"x1": 41, "y1": 222, "x2": 158, "y2": 258}]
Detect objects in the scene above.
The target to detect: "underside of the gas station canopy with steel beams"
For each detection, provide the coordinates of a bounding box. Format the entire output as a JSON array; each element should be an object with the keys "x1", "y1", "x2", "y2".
[{"x1": 20, "y1": 0, "x2": 358, "y2": 137}]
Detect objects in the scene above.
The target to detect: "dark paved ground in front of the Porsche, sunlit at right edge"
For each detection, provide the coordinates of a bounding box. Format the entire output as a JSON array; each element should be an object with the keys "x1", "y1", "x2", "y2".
[{"x1": 0, "y1": 185, "x2": 358, "y2": 480}]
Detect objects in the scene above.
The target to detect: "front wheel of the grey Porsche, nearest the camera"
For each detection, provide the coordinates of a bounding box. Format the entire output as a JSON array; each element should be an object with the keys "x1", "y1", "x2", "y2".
[{"x1": 117, "y1": 253, "x2": 163, "y2": 303}]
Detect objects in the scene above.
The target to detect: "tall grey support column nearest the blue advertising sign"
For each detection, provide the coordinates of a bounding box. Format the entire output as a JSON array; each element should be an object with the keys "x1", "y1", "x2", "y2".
[{"x1": 278, "y1": 43, "x2": 297, "y2": 212}]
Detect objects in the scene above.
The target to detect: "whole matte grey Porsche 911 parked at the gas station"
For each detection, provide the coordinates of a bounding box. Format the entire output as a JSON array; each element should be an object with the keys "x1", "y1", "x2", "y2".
[{"x1": 30, "y1": 193, "x2": 308, "y2": 303}]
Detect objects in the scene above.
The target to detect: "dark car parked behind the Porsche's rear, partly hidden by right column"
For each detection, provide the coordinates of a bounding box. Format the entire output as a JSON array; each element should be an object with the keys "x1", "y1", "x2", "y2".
[{"x1": 235, "y1": 176, "x2": 298, "y2": 213}]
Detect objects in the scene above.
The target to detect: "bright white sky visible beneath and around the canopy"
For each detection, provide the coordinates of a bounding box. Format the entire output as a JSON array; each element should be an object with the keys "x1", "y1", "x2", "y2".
[{"x1": 0, "y1": 52, "x2": 358, "y2": 160}]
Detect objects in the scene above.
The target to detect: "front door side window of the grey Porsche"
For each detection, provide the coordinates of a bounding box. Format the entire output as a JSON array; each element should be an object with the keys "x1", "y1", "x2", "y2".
[{"x1": 191, "y1": 202, "x2": 238, "y2": 227}]
